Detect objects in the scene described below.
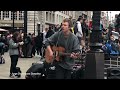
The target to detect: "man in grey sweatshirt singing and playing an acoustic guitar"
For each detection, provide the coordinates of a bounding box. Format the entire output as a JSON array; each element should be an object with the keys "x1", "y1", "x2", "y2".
[{"x1": 45, "y1": 18, "x2": 80, "y2": 79}]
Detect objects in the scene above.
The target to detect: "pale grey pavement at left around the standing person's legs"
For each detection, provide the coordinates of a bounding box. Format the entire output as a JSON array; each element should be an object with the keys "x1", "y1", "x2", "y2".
[{"x1": 0, "y1": 52, "x2": 40, "y2": 79}]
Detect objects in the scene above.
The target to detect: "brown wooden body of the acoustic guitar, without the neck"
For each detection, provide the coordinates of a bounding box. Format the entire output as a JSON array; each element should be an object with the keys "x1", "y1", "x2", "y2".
[{"x1": 45, "y1": 46, "x2": 65, "y2": 63}]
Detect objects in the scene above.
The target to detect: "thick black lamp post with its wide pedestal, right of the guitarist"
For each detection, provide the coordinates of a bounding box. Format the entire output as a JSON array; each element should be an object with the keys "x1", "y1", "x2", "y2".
[{"x1": 85, "y1": 11, "x2": 104, "y2": 79}]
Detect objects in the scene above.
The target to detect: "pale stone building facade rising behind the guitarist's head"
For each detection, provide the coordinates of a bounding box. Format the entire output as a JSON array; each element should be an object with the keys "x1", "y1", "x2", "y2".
[{"x1": 27, "y1": 11, "x2": 76, "y2": 35}]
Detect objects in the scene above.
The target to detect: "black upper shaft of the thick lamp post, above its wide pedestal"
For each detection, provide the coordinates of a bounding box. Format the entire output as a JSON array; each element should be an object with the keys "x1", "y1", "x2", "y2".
[{"x1": 90, "y1": 11, "x2": 102, "y2": 52}]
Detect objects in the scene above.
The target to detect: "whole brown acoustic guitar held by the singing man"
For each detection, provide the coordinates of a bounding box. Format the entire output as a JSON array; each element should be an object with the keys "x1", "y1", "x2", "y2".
[{"x1": 45, "y1": 46, "x2": 80, "y2": 63}]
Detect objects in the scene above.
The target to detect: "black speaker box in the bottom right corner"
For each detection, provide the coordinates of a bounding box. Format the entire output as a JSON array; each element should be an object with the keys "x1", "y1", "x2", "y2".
[{"x1": 107, "y1": 67, "x2": 120, "y2": 79}]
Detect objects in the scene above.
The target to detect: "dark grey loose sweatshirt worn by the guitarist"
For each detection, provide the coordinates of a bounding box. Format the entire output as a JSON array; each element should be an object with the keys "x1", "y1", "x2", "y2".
[{"x1": 45, "y1": 31, "x2": 80, "y2": 69}]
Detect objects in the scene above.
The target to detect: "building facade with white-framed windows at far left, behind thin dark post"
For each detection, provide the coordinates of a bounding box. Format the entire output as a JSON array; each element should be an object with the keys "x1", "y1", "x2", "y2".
[{"x1": 0, "y1": 11, "x2": 24, "y2": 31}]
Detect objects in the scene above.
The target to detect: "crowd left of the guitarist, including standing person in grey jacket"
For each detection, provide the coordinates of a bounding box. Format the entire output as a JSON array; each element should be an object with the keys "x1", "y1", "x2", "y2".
[{"x1": 0, "y1": 24, "x2": 58, "y2": 77}]
